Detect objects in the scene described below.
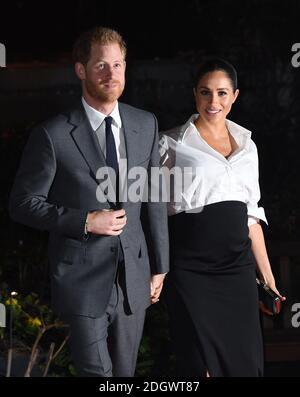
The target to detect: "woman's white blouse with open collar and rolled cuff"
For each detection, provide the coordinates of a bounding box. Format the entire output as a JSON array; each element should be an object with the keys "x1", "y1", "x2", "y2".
[{"x1": 159, "y1": 114, "x2": 267, "y2": 225}]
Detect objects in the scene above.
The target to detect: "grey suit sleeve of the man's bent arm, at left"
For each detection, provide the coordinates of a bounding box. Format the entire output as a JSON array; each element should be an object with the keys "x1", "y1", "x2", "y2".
[{"x1": 9, "y1": 127, "x2": 87, "y2": 239}]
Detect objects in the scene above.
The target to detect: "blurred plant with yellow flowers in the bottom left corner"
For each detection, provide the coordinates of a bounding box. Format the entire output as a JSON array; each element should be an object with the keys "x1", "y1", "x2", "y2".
[{"x1": 0, "y1": 288, "x2": 75, "y2": 377}]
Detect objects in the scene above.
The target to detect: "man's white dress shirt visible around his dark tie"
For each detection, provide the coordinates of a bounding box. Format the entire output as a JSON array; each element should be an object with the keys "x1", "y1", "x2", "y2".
[{"x1": 82, "y1": 98, "x2": 127, "y2": 197}]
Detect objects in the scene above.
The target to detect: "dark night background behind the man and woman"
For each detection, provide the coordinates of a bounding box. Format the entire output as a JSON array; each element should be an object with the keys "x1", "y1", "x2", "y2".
[{"x1": 0, "y1": 0, "x2": 300, "y2": 374}]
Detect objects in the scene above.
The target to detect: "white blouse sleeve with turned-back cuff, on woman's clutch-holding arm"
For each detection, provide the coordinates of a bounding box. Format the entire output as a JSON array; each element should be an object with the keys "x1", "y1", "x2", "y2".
[{"x1": 247, "y1": 141, "x2": 268, "y2": 226}]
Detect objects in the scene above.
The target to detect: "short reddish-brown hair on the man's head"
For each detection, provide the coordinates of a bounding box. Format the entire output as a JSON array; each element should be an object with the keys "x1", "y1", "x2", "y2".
[{"x1": 73, "y1": 26, "x2": 126, "y2": 65}]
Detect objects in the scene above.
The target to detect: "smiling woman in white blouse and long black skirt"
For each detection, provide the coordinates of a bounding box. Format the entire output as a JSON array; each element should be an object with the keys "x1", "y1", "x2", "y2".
[{"x1": 160, "y1": 59, "x2": 285, "y2": 376}]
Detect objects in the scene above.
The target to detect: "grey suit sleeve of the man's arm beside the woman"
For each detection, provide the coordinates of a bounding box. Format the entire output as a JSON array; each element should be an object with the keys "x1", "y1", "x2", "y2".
[{"x1": 147, "y1": 115, "x2": 169, "y2": 274}]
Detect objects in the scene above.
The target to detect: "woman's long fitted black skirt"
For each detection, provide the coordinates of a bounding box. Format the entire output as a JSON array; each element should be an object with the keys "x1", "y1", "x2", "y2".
[{"x1": 165, "y1": 201, "x2": 263, "y2": 376}]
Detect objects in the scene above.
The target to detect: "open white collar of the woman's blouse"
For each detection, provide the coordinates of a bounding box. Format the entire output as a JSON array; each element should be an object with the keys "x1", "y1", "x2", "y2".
[{"x1": 178, "y1": 114, "x2": 251, "y2": 150}]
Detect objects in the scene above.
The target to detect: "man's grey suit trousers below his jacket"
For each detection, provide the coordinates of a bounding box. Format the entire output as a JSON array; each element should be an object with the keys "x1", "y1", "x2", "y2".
[{"x1": 68, "y1": 264, "x2": 145, "y2": 377}]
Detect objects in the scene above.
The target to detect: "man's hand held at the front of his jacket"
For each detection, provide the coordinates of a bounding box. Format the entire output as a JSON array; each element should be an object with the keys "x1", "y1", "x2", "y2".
[{"x1": 87, "y1": 209, "x2": 127, "y2": 236}]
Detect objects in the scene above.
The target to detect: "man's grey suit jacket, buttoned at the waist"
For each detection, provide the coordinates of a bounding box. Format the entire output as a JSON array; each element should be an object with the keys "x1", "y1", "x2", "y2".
[{"x1": 10, "y1": 103, "x2": 169, "y2": 317}]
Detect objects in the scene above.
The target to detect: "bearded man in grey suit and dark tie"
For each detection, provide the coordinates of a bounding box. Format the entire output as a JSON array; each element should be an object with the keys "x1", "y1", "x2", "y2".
[{"x1": 10, "y1": 27, "x2": 168, "y2": 376}]
